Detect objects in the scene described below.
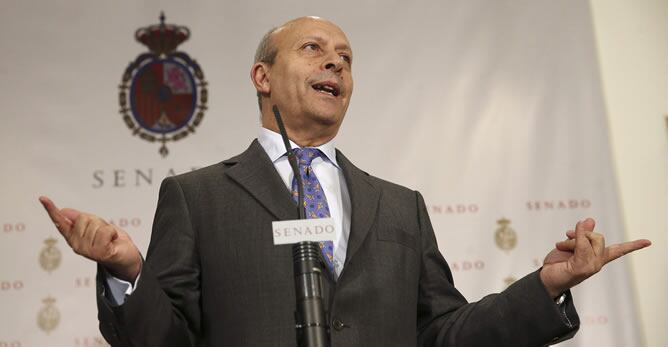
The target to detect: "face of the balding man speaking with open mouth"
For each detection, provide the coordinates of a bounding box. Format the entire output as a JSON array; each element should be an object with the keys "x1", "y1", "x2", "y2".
[{"x1": 268, "y1": 18, "x2": 353, "y2": 132}]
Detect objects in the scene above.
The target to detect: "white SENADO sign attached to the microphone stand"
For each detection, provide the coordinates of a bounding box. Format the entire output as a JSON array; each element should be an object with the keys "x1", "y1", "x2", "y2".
[{"x1": 271, "y1": 218, "x2": 336, "y2": 245}]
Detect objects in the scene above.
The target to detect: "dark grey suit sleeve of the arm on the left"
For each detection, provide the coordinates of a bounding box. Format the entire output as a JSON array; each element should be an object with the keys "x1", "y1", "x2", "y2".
[{"x1": 97, "y1": 177, "x2": 201, "y2": 347}]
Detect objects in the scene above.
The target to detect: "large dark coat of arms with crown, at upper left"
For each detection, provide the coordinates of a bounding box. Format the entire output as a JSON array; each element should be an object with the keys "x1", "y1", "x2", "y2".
[{"x1": 119, "y1": 14, "x2": 208, "y2": 157}]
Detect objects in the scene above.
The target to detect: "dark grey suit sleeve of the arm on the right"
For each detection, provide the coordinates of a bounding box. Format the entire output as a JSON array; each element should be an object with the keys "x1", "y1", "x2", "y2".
[{"x1": 416, "y1": 193, "x2": 579, "y2": 347}]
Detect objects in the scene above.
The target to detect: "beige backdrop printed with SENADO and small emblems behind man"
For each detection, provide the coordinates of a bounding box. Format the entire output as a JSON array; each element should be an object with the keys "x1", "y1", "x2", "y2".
[{"x1": 0, "y1": 0, "x2": 640, "y2": 347}]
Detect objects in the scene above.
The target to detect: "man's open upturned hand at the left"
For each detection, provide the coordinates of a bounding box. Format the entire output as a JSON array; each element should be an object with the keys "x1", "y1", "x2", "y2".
[{"x1": 39, "y1": 196, "x2": 142, "y2": 283}]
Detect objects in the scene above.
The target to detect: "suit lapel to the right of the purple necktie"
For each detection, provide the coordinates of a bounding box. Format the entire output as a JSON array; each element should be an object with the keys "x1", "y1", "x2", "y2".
[{"x1": 336, "y1": 150, "x2": 380, "y2": 272}]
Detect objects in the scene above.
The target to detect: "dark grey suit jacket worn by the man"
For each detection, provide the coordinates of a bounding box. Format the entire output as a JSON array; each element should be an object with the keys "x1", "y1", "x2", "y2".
[{"x1": 97, "y1": 141, "x2": 579, "y2": 346}]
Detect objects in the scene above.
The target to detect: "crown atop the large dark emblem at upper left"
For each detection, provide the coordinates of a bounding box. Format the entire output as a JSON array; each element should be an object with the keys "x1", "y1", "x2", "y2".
[{"x1": 135, "y1": 12, "x2": 190, "y2": 55}]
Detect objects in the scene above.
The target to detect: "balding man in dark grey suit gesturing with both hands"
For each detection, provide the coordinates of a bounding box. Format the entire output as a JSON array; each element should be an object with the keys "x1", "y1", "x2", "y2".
[{"x1": 40, "y1": 17, "x2": 650, "y2": 346}]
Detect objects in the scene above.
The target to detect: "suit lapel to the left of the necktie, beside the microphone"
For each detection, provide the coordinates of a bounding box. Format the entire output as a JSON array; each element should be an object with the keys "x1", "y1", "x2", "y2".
[{"x1": 223, "y1": 140, "x2": 297, "y2": 220}]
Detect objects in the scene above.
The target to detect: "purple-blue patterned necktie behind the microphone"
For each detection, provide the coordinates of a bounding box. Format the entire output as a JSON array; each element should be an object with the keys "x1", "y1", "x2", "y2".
[{"x1": 292, "y1": 148, "x2": 336, "y2": 277}]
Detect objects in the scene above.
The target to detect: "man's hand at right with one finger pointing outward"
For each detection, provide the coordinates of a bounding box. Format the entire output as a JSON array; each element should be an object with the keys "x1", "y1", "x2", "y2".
[{"x1": 540, "y1": 218, "x2": 652, "y2": 298}]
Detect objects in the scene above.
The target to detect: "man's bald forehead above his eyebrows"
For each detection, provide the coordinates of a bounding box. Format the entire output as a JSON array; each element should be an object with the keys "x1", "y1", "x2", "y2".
[{"x1": 274, "y1": 18, "x2": 351, "y2": 50}]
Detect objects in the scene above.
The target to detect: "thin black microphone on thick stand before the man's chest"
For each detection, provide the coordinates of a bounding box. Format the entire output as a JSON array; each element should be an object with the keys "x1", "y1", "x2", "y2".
[{"x1": 272, "y1": 105, "x2": 329, "y2": 347}]
